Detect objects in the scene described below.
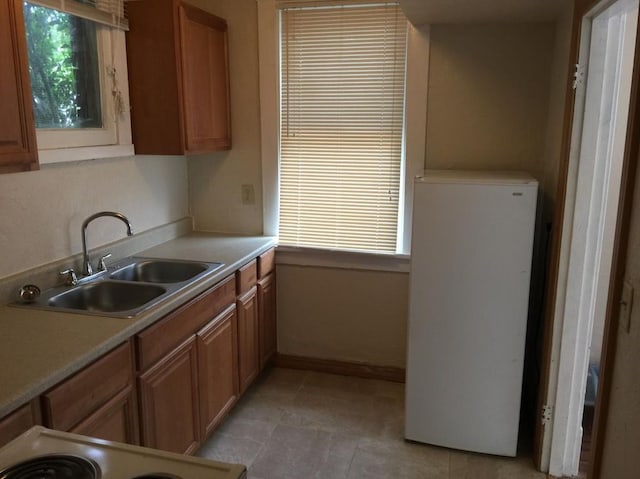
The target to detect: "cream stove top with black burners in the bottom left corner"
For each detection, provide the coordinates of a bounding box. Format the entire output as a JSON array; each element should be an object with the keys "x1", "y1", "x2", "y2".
[{"x1": 0, "y1": 426, "x2": 246, "y2": 479}]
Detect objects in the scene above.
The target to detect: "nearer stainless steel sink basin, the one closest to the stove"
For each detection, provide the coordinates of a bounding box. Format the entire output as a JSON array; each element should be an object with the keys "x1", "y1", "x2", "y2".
[{"x1": 47, "y1": 281, "x2": 167, "y2": 313}]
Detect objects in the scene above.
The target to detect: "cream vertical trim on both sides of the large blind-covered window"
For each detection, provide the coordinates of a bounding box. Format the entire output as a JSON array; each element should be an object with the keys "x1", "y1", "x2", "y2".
[{"x1": 258, "y1": 0, "x2": 429, "y2": 254}]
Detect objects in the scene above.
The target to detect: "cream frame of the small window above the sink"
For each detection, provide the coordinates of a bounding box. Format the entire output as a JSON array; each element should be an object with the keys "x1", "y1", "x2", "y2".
[{"x1": 22, "y1": 2, "x2": 134, "y2": 166}]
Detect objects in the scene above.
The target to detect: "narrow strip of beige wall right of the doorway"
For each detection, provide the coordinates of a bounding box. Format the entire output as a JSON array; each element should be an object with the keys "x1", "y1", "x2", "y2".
[{"x1": 600, "y1": 152, "x2": 640, "y2": 479}]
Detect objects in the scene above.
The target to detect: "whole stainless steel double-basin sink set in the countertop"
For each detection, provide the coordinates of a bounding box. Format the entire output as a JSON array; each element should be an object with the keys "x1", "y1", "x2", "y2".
[{"x1": 19, "y1": 257, "x2": 224, "y2": 318}]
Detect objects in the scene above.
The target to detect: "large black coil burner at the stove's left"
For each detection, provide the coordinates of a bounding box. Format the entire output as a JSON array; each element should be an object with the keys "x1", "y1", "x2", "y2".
[{"x1": 0, "y1": 454, "x2": 101, "y2": 479}]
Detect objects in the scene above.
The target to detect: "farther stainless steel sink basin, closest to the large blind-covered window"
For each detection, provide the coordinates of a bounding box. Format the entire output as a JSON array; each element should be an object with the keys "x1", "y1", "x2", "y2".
[{"x1": 109, "y1": 259, "x2": 212, "y2": 283}]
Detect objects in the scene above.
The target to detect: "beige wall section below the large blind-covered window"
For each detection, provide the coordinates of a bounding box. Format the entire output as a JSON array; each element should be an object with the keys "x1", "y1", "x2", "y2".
[{"x1": 276, "y1": 265, "x2": 409, "y2": 367}]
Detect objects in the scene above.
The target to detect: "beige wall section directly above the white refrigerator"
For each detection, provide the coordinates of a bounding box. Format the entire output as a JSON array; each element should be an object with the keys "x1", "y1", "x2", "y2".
[{"x1": 426, "y1": 24, "x2": 555, "y2": 179}]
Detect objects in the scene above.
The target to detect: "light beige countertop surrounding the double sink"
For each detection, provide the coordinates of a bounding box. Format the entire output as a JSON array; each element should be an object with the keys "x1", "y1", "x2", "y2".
[{"x1": 0, "y1": 232, "x2": 275, "y2": 418}]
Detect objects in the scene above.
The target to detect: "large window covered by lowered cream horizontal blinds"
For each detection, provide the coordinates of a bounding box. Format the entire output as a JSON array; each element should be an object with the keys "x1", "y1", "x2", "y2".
[{"x1": 279, "y1": 4, "x2": 407, "y2": 253}]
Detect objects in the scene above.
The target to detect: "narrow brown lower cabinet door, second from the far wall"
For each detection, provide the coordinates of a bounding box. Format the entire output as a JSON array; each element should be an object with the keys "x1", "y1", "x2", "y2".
[{"x1": 236, "y1": 286, "x2": 260, "y2": 394}]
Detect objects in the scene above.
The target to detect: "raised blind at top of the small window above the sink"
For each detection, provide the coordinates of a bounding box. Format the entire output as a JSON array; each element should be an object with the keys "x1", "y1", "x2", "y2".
[{"x1": 28, "y1": 0, "x2": 129, "y2": 30}]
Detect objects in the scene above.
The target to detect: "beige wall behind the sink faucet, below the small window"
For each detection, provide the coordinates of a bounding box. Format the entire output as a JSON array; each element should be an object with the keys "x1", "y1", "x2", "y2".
[{"x1": 0, "y1": 156, "x2": 188, "y2": 278}]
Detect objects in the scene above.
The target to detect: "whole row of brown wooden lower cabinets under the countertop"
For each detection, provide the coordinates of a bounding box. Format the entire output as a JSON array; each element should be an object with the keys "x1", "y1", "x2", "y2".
[{"x1": 0, "y1": 250, "x2": 276, "y2": 454}]
